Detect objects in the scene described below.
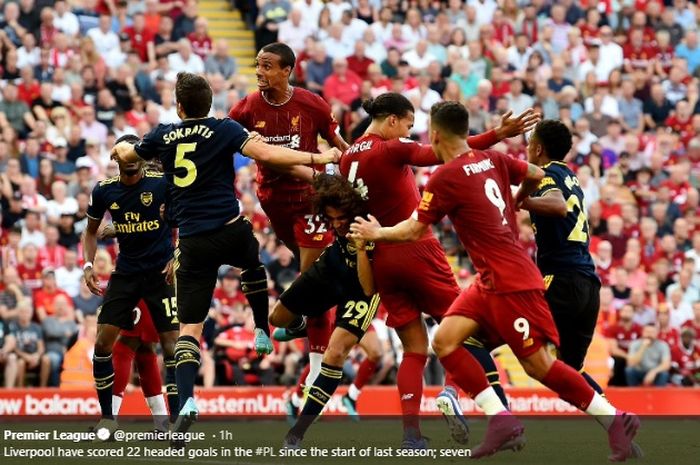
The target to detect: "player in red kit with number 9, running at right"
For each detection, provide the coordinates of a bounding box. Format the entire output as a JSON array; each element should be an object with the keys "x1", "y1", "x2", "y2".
[{"x1": 351, "y1": 102, "x2": 639, "y2": 461}]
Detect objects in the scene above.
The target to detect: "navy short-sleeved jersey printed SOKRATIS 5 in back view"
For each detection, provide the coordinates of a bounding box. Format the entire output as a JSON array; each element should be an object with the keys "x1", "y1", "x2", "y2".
[{"x1": 135, "y1": 118, "x2": 249, "y2": 237}]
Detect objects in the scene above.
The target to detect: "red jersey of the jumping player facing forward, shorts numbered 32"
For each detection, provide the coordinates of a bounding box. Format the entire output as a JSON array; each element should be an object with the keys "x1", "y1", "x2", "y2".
[{"x1": 229, "y1": 87, "x2": 338, "y2": 191}]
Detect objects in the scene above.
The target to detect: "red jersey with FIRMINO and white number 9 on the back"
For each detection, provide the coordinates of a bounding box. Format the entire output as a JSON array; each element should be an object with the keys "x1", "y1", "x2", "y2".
[{"x1": 417, "y1": 150, "x2": 544, "y2": 293}]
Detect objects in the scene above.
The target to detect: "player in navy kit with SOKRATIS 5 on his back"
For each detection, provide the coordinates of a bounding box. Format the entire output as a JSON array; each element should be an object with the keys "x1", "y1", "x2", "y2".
[{"x1": 113, "y1": 72, "x2": 340, "y2": 431}]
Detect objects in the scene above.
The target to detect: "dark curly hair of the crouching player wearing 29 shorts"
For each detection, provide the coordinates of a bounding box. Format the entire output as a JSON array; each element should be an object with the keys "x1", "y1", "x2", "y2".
[{"x1": 313, "y1": 174, "x2": 367, "y2": 219}]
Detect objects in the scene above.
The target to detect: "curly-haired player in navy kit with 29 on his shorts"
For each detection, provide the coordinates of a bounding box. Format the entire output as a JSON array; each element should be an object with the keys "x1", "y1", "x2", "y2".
[{"x1": 270, "y1": 174, "x2": 379, "y2": 447}]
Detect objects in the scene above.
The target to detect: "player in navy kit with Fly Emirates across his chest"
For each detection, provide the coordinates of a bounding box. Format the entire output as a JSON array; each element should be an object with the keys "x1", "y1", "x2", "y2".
[{"x1": 82, "y1": 136, "x2": 179, "y2": 432}]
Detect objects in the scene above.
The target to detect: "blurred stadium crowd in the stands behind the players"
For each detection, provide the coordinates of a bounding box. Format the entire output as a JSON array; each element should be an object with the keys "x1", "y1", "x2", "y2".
[{"x1": 0, "y1": 0, "x2": 700, "y2": 387}]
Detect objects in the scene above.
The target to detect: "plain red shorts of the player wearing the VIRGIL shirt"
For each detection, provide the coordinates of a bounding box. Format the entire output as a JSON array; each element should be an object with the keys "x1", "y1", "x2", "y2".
[{"x1": 372, "y1": 236, "x2": 459, "y2": 328}]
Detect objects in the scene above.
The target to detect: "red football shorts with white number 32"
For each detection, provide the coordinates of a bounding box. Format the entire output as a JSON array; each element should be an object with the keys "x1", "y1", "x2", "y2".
[{"x1": 258, "y1": 189, "x2": 333, "y2": 249}]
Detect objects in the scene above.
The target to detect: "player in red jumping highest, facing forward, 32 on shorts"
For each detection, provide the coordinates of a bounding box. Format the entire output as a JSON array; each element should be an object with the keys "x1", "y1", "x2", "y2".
[{"x1": 229, "y1": 42, "x2": 348, "y2": 402}]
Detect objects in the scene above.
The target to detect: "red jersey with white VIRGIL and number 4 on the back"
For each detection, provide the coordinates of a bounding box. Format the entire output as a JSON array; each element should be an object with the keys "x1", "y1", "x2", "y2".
[{"x1": 340, "y1": 131, "x2": 496, "y2": 226}]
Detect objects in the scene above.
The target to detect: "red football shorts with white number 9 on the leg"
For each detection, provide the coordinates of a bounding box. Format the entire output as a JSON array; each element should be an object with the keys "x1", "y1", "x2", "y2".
[{"x1": 445, "y1": 285, "x2": 559, "y2": 359}]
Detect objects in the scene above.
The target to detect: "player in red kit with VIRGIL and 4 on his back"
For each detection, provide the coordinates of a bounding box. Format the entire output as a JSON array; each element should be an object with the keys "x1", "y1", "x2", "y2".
[{"x1": 340, "y1": 93, "x2": 537, "y2": 447}]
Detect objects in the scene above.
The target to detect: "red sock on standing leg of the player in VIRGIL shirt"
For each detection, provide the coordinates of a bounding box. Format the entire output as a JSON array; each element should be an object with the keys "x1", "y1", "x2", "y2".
[{"x1": 396, "y1": 352, "x2": 428, "y2": 437}]
